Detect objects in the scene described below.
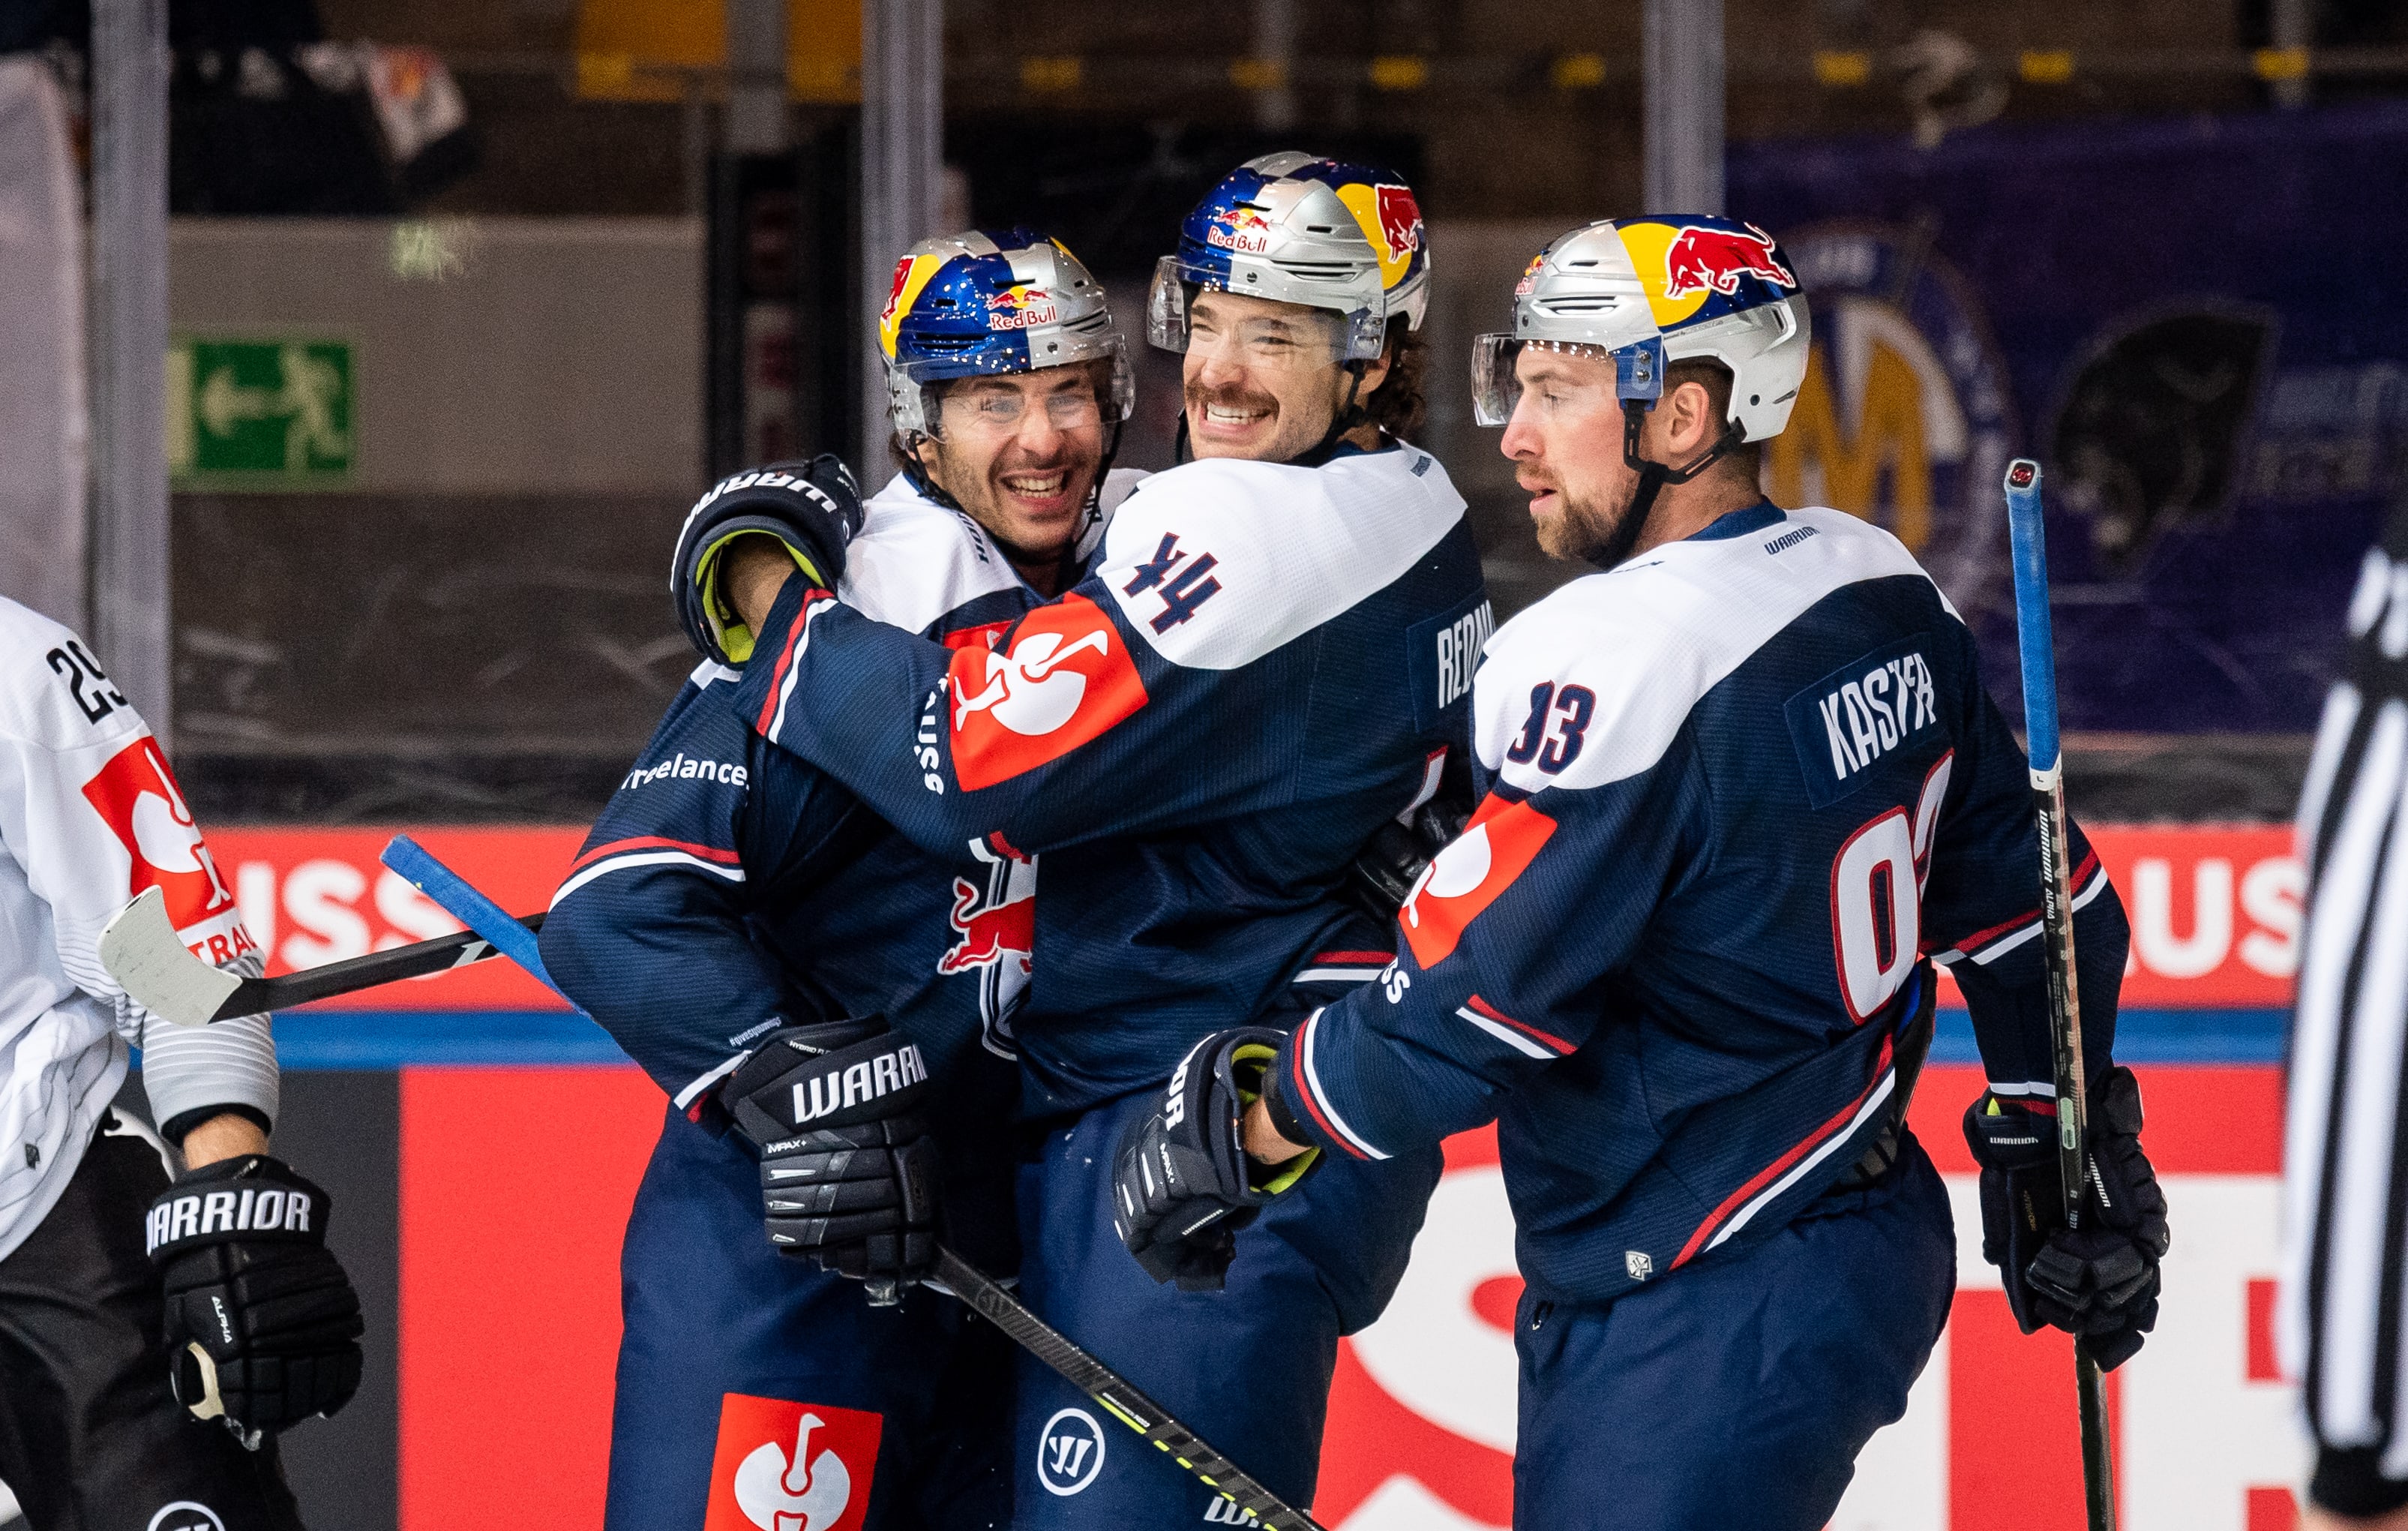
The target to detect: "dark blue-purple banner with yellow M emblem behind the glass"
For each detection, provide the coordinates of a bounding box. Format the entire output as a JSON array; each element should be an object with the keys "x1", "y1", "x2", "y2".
[{"x1": 1729, "y1": 104, "x2": 2408, "y2": 732}]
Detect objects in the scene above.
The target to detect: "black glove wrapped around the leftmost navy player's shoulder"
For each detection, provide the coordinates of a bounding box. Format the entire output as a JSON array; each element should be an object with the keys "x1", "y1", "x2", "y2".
[{"x1": 670, "y1": 452, "x2": 862, "y2": 665}]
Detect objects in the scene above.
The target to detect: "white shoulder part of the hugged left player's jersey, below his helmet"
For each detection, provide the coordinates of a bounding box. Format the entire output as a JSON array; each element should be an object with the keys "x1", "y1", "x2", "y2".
[{"x1": 838, "y1": 467, "x2": 1146, "y2": 633}]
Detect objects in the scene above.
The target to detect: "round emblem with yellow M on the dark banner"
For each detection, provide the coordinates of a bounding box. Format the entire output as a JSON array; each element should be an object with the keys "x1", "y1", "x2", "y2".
[{"x1": 1765, "y1": 224, "x2": 2018, "y2": 629}]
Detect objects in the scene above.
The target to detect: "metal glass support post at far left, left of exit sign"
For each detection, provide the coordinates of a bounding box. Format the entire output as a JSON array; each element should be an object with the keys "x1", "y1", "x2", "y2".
[{"x1": 91, "y1": 0, "x2": 175, "y2": 746}]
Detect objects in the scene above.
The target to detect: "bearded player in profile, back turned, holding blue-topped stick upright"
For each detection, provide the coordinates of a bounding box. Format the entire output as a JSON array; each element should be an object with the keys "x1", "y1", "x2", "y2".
[{"x1": 1117, "y1": 217, "x2": 2167, "y2": 1531}]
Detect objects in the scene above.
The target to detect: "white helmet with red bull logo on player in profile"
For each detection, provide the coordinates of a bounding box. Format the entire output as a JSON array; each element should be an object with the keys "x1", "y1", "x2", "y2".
[{"x1": 1471, "y1": 217, "x2": 1813, "y2": 440}]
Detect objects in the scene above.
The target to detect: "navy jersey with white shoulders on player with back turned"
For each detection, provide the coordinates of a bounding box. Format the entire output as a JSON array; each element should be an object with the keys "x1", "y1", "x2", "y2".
[{"x1": 1276, "y1": 503, "x2": 2126, "y2": 1300}]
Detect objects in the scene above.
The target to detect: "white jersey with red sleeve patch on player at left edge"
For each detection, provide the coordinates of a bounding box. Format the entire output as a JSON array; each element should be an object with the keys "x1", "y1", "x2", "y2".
[{"x1": 0, "y1": 599, "x2": 277, "y2": 1259}]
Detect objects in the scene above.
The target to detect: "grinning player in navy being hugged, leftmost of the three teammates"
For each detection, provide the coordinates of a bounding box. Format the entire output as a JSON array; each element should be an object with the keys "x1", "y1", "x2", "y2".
[{"x1": 541, "y1": 229, "x2": 1137, "y2": 1531}]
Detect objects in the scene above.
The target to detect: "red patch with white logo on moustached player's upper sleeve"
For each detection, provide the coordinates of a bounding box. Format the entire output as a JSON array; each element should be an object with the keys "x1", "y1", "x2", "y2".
[{"x1": 946, "y1": 595, "x2": 1146, "y2": 792}]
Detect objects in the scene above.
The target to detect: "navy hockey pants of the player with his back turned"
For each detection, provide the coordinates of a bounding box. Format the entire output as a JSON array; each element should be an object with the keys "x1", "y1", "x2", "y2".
[{"x1": 1513, "y1": 1136, "x2": 1955, "y2": 1531}]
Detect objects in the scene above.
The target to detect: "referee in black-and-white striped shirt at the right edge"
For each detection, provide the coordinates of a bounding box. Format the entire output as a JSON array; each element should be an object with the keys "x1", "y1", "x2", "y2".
[{"x1": 2281, "y1": 506, "x2": 2408, "y2": 1531}]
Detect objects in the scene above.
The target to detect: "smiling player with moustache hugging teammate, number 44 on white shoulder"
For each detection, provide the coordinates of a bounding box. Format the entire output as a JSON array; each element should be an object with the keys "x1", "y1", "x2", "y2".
[{"x1": 682, "y1": 154, "x2": 1488, "y2": 1529}]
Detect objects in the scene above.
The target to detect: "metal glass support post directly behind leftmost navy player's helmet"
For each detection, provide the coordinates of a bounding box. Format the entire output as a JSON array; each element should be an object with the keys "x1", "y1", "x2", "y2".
[{"x1": 853, "y1": 0, "x2": 944, "y2": 491}]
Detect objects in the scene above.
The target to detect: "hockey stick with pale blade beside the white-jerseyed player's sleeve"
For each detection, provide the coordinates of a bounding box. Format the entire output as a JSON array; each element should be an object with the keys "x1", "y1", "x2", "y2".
[{"x1": 99, "y1": 888, "x2": 544, "y2": 1025}]
